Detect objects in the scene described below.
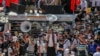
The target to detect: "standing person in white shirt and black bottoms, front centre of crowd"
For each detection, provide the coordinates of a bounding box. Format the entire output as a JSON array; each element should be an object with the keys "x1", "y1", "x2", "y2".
[{"x1": 46, "y1": 28, "x2": 57, "y2": 56}]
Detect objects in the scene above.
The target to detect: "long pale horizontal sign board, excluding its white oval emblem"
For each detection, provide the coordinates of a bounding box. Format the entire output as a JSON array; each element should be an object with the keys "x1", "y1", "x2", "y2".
[{"x1": 8, "y1": 14, "x2": 75, "y2": 21}]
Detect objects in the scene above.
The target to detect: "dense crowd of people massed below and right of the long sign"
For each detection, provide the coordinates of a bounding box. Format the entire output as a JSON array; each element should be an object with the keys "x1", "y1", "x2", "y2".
[{"x1": 0, "y1": 11, "x2": 100, "y2": 56}]
